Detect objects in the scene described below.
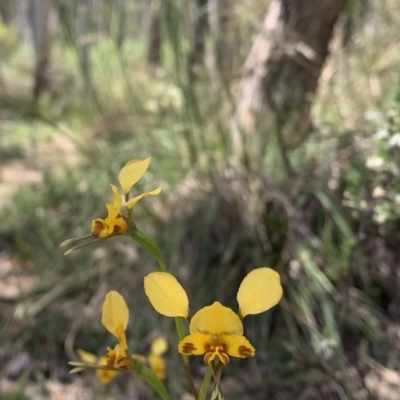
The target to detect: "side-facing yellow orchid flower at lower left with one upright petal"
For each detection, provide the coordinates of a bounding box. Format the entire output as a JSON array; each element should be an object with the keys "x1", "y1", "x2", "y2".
[{"x1": 101, "y1": 290, "x2": 132, "y2": 370}]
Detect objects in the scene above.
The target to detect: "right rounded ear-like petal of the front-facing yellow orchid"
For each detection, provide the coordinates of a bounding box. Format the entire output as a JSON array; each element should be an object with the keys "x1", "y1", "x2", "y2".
[{"x1": 237, "y1": 268, "x2": 283, "y2": 318}]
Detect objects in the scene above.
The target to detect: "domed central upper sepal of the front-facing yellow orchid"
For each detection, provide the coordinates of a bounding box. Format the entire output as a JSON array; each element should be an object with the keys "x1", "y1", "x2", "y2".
[{"x1": 190, "y1": 301, "x2": 243, "y2": 335}]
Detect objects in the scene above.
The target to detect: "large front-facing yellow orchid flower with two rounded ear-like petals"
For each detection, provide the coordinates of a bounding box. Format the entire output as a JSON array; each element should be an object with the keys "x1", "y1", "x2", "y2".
[{"x1": 144, "y1": 268, "x2": 283, "y2": 365}]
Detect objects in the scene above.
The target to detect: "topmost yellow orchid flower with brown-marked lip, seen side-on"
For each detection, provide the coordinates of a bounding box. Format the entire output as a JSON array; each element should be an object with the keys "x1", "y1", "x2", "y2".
[{"x1": 91, "y1": 157, "x2": 161, "y2": 238}]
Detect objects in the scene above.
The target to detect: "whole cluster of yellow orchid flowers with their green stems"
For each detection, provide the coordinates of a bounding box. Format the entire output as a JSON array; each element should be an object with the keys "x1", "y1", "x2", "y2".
[{"x1": 62, "y1": 158, "x2": 282, "y2": 399}]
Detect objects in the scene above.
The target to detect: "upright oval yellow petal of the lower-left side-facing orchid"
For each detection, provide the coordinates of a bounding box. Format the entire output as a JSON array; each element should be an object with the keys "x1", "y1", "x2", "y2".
[{"x1": 101, "y1": 290, "x2": 129, "y2": 341}]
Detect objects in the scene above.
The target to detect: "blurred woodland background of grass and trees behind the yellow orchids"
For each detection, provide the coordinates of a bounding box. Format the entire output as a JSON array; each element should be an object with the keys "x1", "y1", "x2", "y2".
[{"x1": 0, "y1": 0, "x2": 400, "y2": 400}]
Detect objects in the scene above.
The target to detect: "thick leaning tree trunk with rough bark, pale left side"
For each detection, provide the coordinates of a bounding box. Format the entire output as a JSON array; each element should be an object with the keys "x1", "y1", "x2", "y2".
[{"x1": 232, "y1": 0, "x2": 348, "y2": 156}]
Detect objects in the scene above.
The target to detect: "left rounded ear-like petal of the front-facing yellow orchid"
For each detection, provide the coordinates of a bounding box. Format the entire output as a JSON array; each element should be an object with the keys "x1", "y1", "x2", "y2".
[{"x1": 144, "y1": 272, "x2": 189, "y2": 318}]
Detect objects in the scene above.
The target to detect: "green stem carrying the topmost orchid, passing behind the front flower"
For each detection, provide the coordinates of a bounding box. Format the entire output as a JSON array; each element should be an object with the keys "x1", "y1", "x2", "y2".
[{"x1": 130, "y1": 226, "x2": 197, "y2": 398}]
